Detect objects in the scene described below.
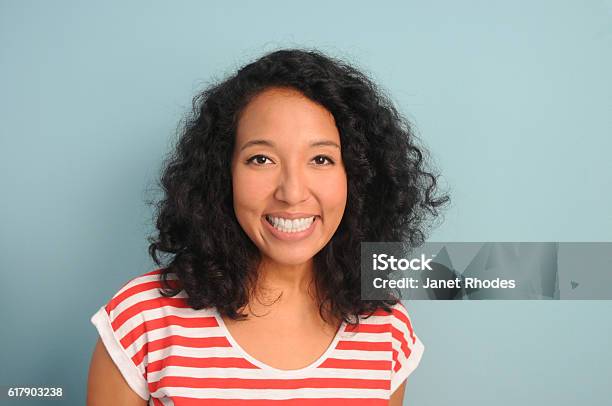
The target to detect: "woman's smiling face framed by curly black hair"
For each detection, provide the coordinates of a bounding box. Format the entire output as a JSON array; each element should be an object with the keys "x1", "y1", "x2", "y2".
[{"x1": 232, "y1": 88, "x2": 347, "y2": 265}]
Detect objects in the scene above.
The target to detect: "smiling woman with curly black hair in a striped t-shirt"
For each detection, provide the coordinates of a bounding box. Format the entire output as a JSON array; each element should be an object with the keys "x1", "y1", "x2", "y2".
[{"x1": 88, "y1": 50, "x2": 447, "y2": 405}]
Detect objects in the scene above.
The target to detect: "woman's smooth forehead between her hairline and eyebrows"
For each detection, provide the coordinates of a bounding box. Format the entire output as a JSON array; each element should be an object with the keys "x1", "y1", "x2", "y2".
[{"x1": 236, "y1": 88, "x2": 339, "y2": 143}]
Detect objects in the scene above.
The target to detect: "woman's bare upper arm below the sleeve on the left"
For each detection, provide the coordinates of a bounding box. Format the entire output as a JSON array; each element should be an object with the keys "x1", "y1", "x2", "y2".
[{"x1": 87, "y1": 339, "x2": 148, "y2": 406}]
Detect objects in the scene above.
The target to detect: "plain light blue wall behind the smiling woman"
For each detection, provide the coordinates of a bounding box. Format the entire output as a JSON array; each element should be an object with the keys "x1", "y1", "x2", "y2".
[{"x1": 0, "y1": 0, "x2": 612, "y2": 406}]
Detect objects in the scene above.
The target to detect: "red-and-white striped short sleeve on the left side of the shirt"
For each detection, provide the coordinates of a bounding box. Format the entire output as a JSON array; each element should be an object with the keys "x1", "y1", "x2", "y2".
[{"x1": 91, "y1": 282, "x2": 150, "y2": 400}]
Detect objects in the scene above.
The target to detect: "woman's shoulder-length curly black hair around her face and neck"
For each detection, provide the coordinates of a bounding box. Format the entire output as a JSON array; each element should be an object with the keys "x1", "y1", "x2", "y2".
[{"x1": 149, "y1": 49, "x2": 449, "y2": 323}]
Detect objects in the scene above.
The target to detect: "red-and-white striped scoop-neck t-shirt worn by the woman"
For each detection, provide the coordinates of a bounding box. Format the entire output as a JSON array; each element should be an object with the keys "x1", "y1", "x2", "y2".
[{"x1": 91, "y1": 269, "x2": 424, "y2": 406}]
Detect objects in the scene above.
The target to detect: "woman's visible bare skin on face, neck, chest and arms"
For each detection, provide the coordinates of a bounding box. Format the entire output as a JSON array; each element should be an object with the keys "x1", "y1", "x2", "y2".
[{"x1": 87, "y1": 88, "x2": 405, "y2": 406}]
